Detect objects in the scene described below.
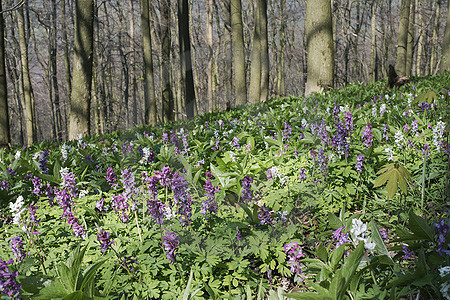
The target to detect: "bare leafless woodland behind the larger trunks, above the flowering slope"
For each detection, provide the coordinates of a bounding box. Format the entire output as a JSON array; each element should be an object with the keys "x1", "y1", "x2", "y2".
[{"x1": 0, "y1": 0, "x2": 449, "y2": 144}]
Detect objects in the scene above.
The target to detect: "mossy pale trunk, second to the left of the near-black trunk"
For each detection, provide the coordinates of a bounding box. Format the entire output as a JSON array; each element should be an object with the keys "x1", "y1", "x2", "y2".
[{"x1": 141, "y1": 0, "x2": 157, "y2": 125}]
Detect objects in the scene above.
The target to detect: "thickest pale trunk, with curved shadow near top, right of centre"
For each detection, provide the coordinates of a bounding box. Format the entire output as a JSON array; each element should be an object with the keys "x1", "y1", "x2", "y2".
[{"x1": 305, "y1": 0, "x2": 334, "y2": 96}]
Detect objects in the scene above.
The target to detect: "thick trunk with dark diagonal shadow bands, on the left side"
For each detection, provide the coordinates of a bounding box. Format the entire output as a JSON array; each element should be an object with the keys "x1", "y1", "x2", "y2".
[{"x1": 69, "y1": 0, "x2": 94, "y2": 140}]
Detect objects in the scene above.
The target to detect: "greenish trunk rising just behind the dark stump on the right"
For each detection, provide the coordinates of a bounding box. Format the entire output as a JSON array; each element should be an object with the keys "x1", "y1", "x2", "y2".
[{"x1": 395, "y1": 0, "x2": 411, "y2": 76}]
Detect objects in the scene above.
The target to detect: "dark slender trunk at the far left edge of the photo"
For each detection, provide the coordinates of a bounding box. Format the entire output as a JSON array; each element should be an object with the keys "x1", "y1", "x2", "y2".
[{"x1": 0, "y1": 0, "x2": 11, "y2": 147}]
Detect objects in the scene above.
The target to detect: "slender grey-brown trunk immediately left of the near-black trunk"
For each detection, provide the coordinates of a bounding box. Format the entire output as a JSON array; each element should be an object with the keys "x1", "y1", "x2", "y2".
[{"x1": 160, "y1": 0, "x2": 175, "y2": 122}]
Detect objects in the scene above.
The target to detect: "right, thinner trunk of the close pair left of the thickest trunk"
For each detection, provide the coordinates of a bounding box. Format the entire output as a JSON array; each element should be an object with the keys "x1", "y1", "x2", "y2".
[{"x1": 259, "y1": 0, "x2": 270, "y2": 102}]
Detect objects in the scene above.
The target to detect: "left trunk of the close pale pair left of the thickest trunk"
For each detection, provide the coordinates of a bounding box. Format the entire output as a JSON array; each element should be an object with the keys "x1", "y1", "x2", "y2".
[{"x1": 249, "y1": 1, "x2": 261, "y2": 103}]
